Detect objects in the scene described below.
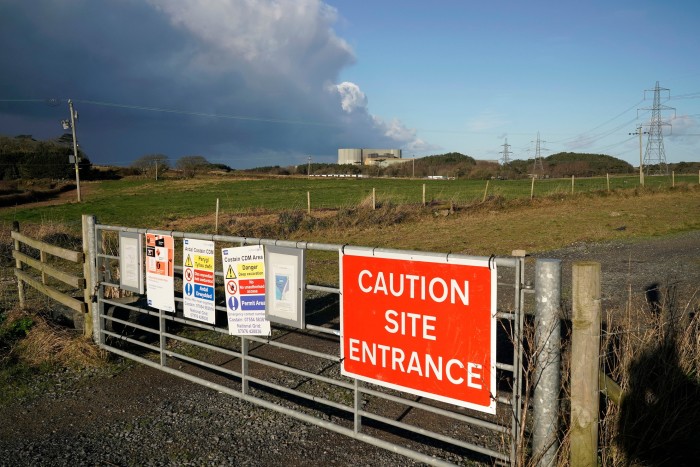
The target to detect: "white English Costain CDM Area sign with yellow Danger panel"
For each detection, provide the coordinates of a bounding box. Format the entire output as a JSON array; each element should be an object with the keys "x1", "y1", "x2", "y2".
[{"x1": 221, "y1": 245, "x2": 270, "y2": 335}]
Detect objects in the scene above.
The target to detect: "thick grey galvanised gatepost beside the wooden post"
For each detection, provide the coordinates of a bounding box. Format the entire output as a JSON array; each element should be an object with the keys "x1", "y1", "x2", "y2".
[{"x1": 532, "y1": 259, "x2": 561, "y2": 466}]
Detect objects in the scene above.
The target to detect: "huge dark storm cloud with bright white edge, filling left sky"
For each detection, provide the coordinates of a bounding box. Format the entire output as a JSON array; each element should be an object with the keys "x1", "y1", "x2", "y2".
[{"x1": 0, "y1": 0, "x2": 423, "y2": 167}]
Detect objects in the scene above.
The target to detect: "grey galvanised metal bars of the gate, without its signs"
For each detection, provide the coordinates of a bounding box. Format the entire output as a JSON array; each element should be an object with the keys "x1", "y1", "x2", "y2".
[{"x1": 89, "y1": 222, "x2": 552, "y2": 465}]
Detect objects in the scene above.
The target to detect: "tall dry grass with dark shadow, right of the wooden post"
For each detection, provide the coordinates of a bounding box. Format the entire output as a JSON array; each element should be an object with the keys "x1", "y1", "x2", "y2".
[{"x1": 599, "y1": 291, "x2": 700, "y2": 466}]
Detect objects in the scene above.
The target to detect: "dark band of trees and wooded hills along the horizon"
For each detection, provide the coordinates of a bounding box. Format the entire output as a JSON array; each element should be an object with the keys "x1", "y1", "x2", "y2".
[{"x1": 0, "y1": 134, "x2": 700, "y2": 181}]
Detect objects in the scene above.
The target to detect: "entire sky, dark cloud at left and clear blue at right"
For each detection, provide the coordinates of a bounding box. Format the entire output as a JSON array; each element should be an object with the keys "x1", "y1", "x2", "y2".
[{"x1": 0, "y1": 0, "x2": 700, "y2": 168}]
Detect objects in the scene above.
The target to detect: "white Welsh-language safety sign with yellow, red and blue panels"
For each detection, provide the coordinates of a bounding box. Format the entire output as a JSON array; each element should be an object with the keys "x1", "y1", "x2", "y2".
[{"x1": 182, "y1": 238, "x2": 216, "y2": 324}]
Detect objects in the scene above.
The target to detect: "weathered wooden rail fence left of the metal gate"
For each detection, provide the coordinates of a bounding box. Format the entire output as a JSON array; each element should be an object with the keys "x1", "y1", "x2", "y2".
[{"x1": 11, "y1": 222, "x2": 87, "y2": 313}]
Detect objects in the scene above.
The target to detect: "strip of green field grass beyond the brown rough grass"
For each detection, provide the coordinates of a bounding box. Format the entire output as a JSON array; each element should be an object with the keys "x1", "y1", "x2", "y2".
[{"x1": 0, "y1": 175, "x2": 698, "y2": 228}]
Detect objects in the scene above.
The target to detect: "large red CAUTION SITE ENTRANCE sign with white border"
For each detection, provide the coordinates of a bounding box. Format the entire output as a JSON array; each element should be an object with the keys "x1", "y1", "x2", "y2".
[{"x1": 340, "y1": 247, "x2": 497, "y2": 414}]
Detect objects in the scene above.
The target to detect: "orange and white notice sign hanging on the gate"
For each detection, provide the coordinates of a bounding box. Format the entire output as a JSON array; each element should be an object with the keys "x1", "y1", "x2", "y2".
[{"x1": 146, "y1": 233, "x2": 175, "y2": 312}]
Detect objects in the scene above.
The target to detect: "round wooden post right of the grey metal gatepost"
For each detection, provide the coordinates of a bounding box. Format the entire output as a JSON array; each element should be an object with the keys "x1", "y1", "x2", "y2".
[{"x1": 570, "y1": 261, "x2": 601, "y2": 467}]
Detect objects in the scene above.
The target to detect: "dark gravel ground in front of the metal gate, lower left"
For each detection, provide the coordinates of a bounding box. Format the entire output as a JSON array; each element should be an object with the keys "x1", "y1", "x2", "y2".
[{"x1": 0, "y1": 364, "x2": 422, "y2": 466}]
